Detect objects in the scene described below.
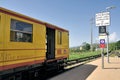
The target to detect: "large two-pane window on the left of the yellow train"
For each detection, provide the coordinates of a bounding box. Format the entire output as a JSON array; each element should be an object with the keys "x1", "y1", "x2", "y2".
[{"x1": 10, "y1": 19, "x2": 33, "y2": 42}]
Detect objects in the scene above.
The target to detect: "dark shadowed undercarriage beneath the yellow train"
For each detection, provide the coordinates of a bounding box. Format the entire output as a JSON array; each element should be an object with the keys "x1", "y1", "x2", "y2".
[{"x1": 0, "y1": 59, "x2": 65, "y2": 80}]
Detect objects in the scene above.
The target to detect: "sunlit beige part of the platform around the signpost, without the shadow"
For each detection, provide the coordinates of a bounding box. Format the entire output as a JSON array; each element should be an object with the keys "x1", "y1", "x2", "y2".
[{"x1": 86, "y1": 57, "x2": 120, "y2": 80}]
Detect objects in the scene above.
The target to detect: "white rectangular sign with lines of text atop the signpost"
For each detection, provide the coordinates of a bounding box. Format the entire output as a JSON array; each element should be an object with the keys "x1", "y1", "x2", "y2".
[{"x1": 96, "y1": 12, "x2": 110, "y2": 26}]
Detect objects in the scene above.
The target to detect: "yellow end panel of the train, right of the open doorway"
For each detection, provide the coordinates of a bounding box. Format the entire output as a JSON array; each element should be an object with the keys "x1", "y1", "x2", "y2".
[{"x1": 55, "y1": 30, "x2": 69, "y2": 58}]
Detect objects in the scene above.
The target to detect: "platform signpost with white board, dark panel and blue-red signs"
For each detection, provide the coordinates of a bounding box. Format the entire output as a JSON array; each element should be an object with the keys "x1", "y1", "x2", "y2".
[{"x1": 95, "y1": 12, "x2": 110, "y2": 68}]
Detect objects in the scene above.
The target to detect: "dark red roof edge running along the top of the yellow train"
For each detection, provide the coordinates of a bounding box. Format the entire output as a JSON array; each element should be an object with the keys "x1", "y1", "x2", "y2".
[{"x1": 0, "y1": 7, "x2": 69, "y2": 32}]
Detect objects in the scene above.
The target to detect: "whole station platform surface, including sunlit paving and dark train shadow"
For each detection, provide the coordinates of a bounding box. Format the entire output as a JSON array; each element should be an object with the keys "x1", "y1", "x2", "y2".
[{"x1": 47, "y1": 57, "x2": 120, "y2": 80}]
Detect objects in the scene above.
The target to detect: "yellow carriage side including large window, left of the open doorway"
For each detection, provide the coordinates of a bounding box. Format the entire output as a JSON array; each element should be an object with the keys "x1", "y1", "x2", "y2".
[{"x1": 0, "y1": 7, "x2": 46, "y2": 70}]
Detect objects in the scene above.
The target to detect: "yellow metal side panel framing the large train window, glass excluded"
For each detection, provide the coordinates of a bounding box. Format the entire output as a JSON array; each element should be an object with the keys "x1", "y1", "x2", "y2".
[{"x1": 1, "y1": 15, "x2": 46, "y2": 65}]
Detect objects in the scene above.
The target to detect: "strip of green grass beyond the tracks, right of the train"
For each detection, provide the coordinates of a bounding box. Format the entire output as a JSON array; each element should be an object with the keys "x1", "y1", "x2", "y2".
[{"x1": 69, "y1": 51, "x2": 101, "y2": 60}]
